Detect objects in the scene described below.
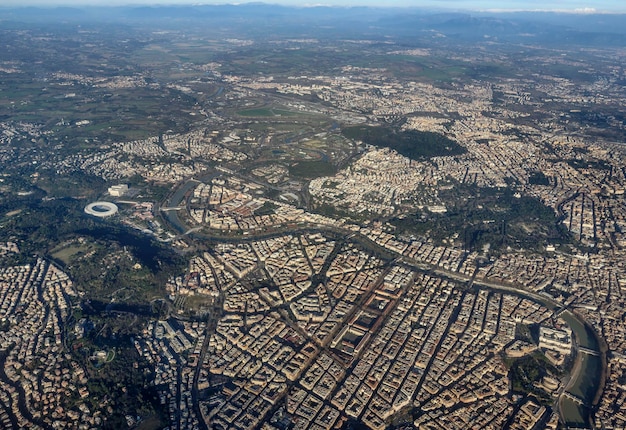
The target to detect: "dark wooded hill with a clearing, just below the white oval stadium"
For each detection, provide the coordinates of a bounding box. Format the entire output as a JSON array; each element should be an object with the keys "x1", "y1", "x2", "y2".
[{"x1": 0, "y1": 195, "x2": 182, "y2": 303}]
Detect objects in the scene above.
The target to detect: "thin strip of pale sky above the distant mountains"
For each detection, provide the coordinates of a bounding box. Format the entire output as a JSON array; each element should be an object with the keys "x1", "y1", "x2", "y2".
[{"x1": 0, "y1": 0, "x2": 626, "y2": 12}]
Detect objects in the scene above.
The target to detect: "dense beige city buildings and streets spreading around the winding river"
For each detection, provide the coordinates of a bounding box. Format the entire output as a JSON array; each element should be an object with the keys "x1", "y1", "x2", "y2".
[{"x1": 0, "y1": 33, "x2": 626, "y2": 429}]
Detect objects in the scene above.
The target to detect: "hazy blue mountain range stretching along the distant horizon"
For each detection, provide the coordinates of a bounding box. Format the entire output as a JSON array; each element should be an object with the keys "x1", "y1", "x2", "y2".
[{"x1": 0, "y1": 3, "x2": 626, "y2": 46}]
